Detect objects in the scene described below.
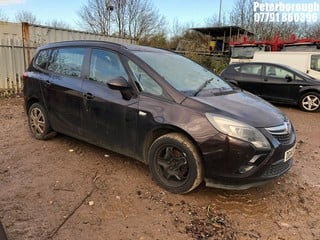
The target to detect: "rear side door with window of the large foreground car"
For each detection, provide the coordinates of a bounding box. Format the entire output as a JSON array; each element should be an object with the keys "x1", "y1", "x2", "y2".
[{"x1": 41, "y1": 47, "x2": 86, "y2": 136}]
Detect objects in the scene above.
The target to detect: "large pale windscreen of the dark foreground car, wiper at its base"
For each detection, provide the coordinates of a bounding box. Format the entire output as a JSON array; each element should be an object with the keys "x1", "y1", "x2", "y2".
[{"x1": 134, "y1": 51, "x2": 232, "y2": 95}]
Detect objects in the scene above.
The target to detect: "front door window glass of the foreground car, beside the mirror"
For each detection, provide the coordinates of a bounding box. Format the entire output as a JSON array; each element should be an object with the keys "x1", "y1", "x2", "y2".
[{"x1": 89, "y1": 49, "x2": 128, "y2": 83}]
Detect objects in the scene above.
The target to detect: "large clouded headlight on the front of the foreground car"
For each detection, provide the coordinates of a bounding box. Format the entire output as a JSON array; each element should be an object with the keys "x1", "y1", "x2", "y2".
[{"x1": 206, "y1": 113, "x2": 270, "y2": 149}]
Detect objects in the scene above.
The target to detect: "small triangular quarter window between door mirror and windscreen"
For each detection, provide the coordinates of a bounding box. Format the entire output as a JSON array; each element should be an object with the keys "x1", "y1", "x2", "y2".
[{"x1": 128, "y1": 60, "x2": 163, "y2": 96}]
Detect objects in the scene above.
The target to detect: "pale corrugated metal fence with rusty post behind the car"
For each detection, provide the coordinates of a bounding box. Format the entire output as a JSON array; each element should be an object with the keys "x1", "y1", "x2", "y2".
[{"x1": 0, "y1": 22, "x2": 135, "y2": 96}]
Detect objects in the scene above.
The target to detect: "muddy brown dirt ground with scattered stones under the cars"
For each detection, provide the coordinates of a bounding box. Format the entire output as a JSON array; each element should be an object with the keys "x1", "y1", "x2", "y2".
[{"x1": 0, "y1": 97, "x2": 320, "y2": 240}]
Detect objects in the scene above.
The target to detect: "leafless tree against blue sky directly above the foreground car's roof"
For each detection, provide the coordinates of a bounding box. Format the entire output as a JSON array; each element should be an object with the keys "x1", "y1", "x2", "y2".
[{"x1": 79, "y1": 0, "x2": 165, "y2": 39}]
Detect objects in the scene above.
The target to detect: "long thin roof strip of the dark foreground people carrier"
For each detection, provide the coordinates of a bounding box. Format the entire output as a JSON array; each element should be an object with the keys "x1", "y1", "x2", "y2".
[{"x1": 38, "y1": 40, "x2": 170, "y2": 53}]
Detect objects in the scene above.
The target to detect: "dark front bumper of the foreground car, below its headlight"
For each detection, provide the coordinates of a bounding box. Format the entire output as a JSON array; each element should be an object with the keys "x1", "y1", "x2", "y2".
[{"x1": 201, "y1": 125, "x2": 296, "y2": 190}]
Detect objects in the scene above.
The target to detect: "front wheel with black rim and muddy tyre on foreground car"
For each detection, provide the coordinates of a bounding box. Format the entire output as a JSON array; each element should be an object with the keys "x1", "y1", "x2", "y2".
[{"x1": 148, "y1": 133, "x2": 203, "y2": 194}]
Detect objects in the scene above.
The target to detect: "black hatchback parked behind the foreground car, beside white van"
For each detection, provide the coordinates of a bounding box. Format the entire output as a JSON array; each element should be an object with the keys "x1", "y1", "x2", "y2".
[{"x1": 220, "y1": 62, "x2": 320, "y2": 112}]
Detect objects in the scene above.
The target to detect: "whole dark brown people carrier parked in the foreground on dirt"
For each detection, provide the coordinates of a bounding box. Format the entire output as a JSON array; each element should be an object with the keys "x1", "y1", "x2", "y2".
[{"x1": 24, "y1": 41, "x2": 295, "y2": 193}]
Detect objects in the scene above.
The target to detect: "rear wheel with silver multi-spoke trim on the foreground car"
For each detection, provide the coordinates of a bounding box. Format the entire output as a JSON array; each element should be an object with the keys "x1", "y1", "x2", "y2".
[{"x1": 28, "y1": 103, "x2": 55, "y2": 140}]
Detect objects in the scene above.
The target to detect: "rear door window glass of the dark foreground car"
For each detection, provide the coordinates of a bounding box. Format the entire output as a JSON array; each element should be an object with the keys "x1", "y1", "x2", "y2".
[{"x1": 48, "y1": 47, "x2": 86, "y2": 77}]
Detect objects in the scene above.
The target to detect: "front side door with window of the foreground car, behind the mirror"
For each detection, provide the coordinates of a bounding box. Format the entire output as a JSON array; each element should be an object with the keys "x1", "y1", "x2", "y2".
[{"x1": 81, "y1": 49, "x2": 138, "y2": 156}]
